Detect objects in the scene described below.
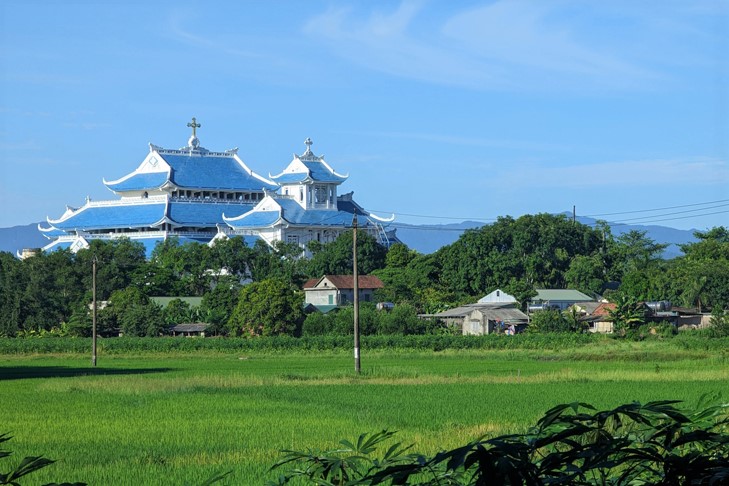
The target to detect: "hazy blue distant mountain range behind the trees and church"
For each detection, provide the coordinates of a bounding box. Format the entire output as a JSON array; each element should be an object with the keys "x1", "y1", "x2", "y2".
[{"x1": 0, "y1": 217, "x2": 696, "y2": 258}]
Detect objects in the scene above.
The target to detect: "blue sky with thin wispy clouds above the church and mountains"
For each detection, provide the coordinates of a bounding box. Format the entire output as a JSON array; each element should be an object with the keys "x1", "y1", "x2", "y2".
[{"x1": 0, "y1": 0, "x2": 729, "y2": 229}]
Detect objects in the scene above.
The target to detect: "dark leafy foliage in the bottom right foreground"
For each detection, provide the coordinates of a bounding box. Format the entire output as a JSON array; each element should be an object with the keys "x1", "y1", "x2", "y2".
[{"x1": 271, "y1": 400, "x2": 729, "y2": 485}]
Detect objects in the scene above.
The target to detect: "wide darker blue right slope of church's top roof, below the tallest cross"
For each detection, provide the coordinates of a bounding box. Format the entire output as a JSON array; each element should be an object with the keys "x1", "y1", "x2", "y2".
[{"x1": 160, "y1": 153, "x2": 276, "y2": 191}]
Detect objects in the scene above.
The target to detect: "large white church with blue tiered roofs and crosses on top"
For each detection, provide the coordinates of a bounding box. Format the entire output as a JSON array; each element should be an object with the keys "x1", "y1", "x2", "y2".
[{"x1": 38, "y1": 118, "x2": 396, "y2": 257}]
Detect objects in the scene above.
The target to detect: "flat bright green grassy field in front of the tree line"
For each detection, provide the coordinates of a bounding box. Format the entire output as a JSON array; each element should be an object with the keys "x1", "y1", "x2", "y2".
[{"x1": 0, "y1": 342, "x2": 729, "y2": 485}]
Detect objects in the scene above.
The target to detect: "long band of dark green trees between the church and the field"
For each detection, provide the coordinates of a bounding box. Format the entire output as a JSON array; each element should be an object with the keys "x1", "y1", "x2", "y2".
[{"x1": 0, "y1": 214, "x2": 729, "y2": 336}]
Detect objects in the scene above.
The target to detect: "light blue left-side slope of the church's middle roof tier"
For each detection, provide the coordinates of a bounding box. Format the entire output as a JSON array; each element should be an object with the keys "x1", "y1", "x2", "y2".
[{"x1": 49, "y1": 202, "x2": 167, "y2": 231}]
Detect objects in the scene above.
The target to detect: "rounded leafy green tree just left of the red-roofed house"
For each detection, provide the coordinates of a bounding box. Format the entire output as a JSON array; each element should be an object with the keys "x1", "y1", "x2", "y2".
[{"x1": 228, "y1": 278, "x2": 304, "y2": 336}]
